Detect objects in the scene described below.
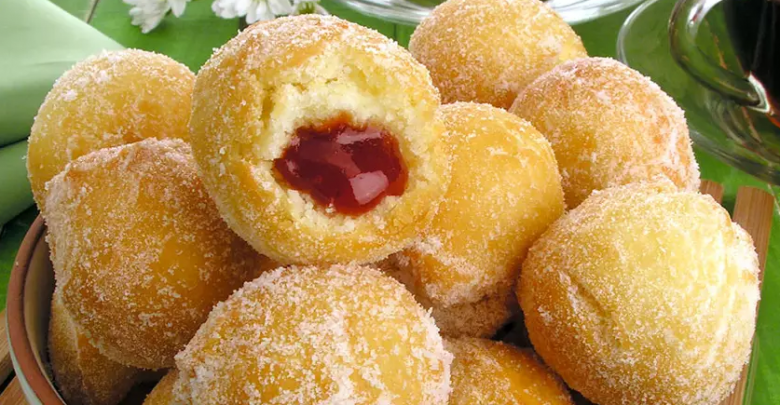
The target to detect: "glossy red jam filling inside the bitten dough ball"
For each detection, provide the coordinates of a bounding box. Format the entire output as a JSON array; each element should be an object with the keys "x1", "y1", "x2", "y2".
[{"x1": 274, "y1": 117, "x2": 408, "y2": 216}]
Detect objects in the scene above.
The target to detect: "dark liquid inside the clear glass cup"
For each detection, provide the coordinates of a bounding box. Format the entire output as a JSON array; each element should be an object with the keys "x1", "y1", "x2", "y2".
[{"x1": 723, "y1": 0, "x2": 780, "y2": 109}]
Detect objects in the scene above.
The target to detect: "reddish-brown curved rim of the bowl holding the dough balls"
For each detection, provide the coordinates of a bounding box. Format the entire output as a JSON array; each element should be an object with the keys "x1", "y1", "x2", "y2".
[{"x1": 6, "y1": 215, "x2": 66, "y2": 405}]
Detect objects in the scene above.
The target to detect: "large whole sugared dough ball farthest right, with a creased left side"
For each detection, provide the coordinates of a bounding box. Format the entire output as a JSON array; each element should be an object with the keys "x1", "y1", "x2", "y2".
[{"x1": 518, "y1": 182, "x2": 759, "y2": 405}]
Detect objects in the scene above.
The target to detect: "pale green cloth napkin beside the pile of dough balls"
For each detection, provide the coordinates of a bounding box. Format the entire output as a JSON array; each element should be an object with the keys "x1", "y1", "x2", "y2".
[{"x1": 0, "y1": 0, "x2": 122, "y2": 225}]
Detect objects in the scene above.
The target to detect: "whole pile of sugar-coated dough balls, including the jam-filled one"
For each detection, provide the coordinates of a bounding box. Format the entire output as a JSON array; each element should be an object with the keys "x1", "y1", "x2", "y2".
[{"x1": 28, "y1": 0, "x2": 758, "y2": 405}]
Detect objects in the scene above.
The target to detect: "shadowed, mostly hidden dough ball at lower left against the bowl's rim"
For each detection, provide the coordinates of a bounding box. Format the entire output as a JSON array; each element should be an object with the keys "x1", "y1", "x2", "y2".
[{"x1": 48, "y1": 292, "x2": 141, "y2": 405}]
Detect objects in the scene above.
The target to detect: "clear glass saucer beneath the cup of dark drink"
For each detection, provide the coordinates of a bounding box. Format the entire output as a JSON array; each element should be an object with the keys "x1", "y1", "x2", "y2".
[{"x1": 617, "y1": 0, "x2": 780, "y2": 184}]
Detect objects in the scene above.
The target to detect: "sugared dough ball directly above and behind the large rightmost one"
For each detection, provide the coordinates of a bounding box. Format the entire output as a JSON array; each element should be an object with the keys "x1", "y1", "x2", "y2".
[{"x1": 510, "y1": 58, "x2": 699, "y2": 208}]
